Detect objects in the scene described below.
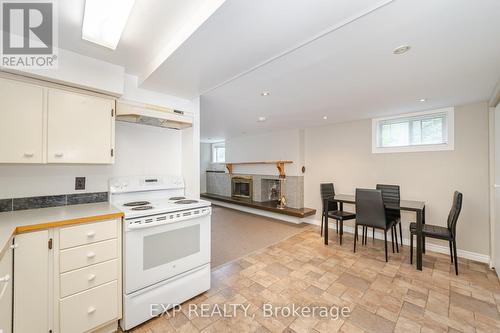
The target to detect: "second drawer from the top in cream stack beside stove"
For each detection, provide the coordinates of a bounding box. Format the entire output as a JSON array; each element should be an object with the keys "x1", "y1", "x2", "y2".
[{"x1": 59, "y1": 239, "x2": 118, "y2": 273}]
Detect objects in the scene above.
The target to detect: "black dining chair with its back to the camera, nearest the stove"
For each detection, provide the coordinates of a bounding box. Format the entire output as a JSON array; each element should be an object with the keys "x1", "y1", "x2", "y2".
[{"x1": 354, "y1": 188, "x2": 394, "y2": 262}]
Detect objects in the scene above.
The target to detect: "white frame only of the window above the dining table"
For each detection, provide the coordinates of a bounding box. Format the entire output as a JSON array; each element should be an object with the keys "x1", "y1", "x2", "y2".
[{"x1": 372, "y1": 107, "x2": 455, "y2": 154}]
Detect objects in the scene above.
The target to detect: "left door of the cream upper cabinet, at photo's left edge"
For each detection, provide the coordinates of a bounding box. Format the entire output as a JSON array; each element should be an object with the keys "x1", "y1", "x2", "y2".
[{"x1": 0, "y1": 79, "x2": 44, "y2": 163}]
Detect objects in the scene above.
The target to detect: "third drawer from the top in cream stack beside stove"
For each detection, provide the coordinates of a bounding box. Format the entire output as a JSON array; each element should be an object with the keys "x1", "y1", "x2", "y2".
[{"x1": 60, "y1": 260, "x2": 118, "y2": 298}]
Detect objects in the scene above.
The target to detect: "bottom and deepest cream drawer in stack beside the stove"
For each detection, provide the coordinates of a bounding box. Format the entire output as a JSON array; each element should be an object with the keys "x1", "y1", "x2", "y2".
[{"x1": 60, "y1": 281, "x2": 118, "y2": 333}]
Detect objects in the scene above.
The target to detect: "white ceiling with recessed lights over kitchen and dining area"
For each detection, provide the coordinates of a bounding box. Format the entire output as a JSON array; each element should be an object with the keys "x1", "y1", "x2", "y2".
[{"x1": 58, "y1": 0, "x2": 500, "y2": 140}]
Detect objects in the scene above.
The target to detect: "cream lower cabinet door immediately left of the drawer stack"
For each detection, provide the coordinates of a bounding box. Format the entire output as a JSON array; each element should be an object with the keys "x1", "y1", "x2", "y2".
[{"x1": 14, "y1": 230, "x2": 50, "y2": 333}]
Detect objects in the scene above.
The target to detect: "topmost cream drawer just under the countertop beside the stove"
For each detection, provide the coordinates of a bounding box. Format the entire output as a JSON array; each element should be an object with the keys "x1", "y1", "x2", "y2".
[{"x1": 59, "y1": 221, "x2": 117, "y2": 249}]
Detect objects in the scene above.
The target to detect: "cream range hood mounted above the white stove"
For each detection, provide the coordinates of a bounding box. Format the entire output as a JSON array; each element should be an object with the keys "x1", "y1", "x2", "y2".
[{"x1": 116, "y1": 100, "x2": 193, "y2": 129}]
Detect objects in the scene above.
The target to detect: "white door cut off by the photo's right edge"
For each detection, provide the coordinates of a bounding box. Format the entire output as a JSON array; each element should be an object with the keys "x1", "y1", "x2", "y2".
[{"x1": 493, "y1": 104, "x2": 500, "y2": 277}]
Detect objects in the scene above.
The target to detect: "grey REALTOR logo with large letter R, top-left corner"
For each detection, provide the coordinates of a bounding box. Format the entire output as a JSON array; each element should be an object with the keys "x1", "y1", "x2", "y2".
[{"x1": 1, "y1": 0, "x2": 57, "y2": 69}]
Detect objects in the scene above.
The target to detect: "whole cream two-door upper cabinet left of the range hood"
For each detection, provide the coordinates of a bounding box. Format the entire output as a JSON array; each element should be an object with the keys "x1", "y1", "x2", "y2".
[{"x1": 0, "y1": 76, "x2": 115, "y2": 164}]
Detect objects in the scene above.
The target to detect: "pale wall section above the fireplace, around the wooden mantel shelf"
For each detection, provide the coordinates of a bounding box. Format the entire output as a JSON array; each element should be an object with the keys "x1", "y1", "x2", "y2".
[{"x1": 226, "y1": 129, "x2": 304, "y2": 176}]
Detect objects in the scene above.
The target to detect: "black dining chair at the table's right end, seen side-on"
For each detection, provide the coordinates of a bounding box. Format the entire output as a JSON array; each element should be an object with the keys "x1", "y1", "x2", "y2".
[{"x1": 410, "y1": 191, "x2": 463, "y2": 275}]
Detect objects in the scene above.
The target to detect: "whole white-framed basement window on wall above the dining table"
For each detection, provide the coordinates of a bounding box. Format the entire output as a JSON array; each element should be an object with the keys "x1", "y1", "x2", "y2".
[{"x1": 372, "y1": 108, "x2": 454, "y2": 153}]
